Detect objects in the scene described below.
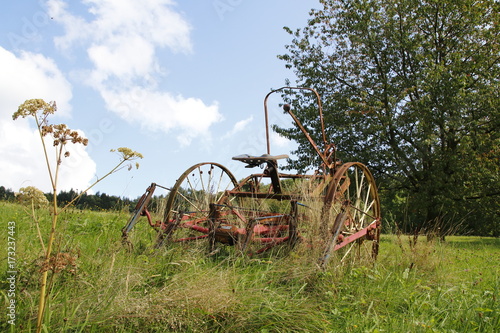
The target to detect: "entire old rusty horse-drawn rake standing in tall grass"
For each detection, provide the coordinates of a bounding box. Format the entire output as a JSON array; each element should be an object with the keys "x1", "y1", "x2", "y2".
[{"x1": 122, "y1": 87, "x2": 381, "y2": 266}]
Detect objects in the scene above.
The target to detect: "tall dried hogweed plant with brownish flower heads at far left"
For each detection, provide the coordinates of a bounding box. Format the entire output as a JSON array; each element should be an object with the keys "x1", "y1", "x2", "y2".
[{"x1": 12, "y1": 99, "x2": 143, "y2": 333}]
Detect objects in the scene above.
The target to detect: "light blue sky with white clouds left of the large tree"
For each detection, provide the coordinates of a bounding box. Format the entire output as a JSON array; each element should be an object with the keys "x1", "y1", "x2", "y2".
[{"x1": 0, "y1": 0, "x2": 319, "y2": 198}]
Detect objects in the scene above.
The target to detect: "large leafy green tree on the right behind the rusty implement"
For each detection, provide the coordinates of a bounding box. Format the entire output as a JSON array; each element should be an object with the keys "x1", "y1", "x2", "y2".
[{"x1": 275, "y1": 0, "x2": 500, "y2": 235}]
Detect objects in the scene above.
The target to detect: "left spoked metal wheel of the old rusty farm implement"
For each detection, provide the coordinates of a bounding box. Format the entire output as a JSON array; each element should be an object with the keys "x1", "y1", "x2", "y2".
[{"x1": 156, "y1": 162, "x2": 241, "y2": 247}]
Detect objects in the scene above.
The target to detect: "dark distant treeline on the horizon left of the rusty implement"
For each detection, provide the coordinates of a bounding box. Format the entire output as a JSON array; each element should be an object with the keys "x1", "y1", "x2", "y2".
[{"x1": 0, "y1": 186, "x2": 138, "y2": 210}]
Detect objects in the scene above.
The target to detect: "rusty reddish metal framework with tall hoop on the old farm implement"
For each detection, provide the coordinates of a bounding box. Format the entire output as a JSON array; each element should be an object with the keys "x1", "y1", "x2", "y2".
[{"x1": 122, "y1": 86, "x2": 381, "y2": 264}]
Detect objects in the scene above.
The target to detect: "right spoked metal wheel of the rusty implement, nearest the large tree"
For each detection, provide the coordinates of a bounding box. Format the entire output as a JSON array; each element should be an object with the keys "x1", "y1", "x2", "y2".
[{"x1": 320, "y1": 162, "x2": 381, "y2": 266}]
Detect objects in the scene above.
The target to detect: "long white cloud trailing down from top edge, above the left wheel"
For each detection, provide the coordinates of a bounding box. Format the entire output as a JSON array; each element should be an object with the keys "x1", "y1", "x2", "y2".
[{"x1": 48, "y1": 0, "x2": 222, "y2": 145}]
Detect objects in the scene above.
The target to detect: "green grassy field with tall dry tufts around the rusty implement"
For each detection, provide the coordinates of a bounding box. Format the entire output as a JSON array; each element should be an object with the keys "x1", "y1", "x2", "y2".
[{"x1": 0, "y1": 202, "x2": 500, "y2": 333}]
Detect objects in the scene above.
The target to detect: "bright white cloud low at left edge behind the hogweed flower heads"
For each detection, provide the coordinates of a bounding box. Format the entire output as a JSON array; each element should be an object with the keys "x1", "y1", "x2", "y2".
[{"x1": 0, "y1": 47, "x2": 96, "y2": 192}]
